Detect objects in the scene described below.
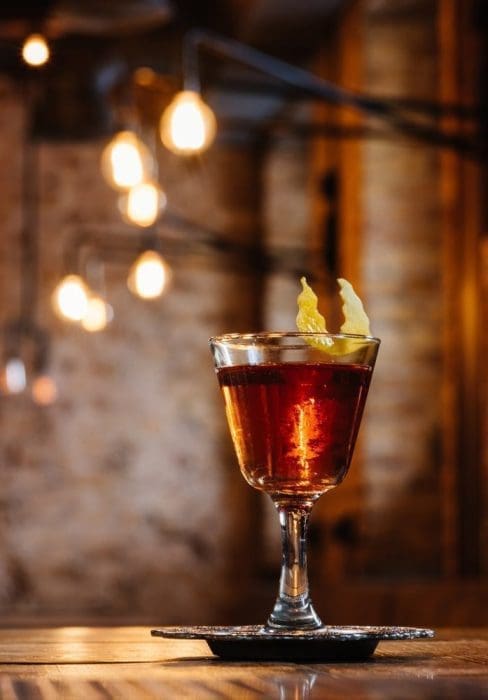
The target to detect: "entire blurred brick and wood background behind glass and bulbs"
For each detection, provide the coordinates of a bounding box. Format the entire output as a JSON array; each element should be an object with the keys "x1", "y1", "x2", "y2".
[{"x1": 0, "y1": 0, "x2": 488, "y2": 625}]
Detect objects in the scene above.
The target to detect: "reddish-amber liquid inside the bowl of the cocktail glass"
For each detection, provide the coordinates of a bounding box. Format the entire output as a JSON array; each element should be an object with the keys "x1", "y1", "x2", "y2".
[{"x1": 217, "y1": 362, "x2": 371, "y2": 496}]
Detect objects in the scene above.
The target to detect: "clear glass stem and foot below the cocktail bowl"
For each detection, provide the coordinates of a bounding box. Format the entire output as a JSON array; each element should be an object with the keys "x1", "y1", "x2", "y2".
[{"x1": 267, "y1": 500, "x2": 322, "y2": 629}]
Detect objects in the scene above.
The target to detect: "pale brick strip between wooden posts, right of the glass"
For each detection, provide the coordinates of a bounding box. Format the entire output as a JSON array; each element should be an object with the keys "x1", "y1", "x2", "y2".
[{"x1": 363, "y1": 2, "x2": 442, "y2": 576}]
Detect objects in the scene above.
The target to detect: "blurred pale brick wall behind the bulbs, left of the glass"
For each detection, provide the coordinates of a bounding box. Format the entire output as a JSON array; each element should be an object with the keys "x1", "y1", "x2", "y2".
[{"x1": 0, "y1": 81, "x2": 259, "y2": 623}]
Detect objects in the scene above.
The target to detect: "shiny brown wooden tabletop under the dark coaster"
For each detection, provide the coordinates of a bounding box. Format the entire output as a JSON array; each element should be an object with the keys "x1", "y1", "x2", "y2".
[{"x1": 0, "y1": 627, "x2": 488, "y2": 700}]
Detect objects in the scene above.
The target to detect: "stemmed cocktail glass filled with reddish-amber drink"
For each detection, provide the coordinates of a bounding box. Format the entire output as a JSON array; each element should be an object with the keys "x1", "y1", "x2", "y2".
[{"x1": 210, "y1": 332, "x2": 380, "y2": 630}]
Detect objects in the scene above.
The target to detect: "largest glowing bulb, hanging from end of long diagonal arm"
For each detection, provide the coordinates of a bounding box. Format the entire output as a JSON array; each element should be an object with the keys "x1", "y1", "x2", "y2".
[{"x1": 160, "y1": 90, "x2": 217, "y2": 155}]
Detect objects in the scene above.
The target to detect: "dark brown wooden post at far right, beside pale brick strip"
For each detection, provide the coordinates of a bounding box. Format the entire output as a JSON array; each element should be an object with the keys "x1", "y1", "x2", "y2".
[{"x1": 439, "y1": 0, "x2": 483, "y2": 575}]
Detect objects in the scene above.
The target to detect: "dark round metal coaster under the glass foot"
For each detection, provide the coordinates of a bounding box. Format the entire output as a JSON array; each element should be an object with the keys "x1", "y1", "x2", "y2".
[{"x1": 151, "y1": 625, "x2": 434, "y2": 661}]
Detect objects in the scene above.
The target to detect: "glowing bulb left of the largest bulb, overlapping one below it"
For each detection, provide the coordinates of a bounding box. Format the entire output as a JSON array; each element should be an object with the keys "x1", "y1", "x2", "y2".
[{"x1": 101, "y1": 131, "x2": 152, "y2": 190}]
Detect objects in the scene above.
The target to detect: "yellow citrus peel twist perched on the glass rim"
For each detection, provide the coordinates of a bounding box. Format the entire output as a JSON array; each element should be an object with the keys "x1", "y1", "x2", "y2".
[{"x1": 296, "y1": 277, "x2": 371, "y2": 355}]
